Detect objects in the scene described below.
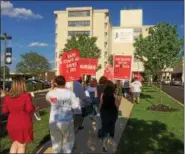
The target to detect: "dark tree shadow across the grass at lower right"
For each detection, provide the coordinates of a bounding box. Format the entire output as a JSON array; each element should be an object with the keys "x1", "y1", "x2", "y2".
[{"x1": 116, "y1": 119, "x2": 184, "y2": 154}]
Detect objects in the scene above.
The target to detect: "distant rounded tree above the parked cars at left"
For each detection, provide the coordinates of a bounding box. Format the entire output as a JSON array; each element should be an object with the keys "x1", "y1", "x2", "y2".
[{"x1": 16, "y1": 52, "x2": 49, "y2": 76}]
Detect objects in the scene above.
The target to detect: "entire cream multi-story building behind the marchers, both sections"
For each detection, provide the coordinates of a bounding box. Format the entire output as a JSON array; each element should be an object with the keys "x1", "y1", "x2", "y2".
[{"x1": 54, "y1": 7, "x2": 150, "y2": 78}]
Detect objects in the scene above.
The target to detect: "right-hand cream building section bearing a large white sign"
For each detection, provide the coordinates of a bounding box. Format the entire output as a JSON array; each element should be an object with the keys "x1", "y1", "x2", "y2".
[{"x1": 110, "y1": 9, "x2": 151, "y2": 75}]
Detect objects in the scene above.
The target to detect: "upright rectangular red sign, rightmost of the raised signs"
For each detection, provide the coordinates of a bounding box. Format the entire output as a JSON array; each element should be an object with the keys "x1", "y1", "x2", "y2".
[{"x1": 114, "y1": 55, "x2": 132, "y2": 80}]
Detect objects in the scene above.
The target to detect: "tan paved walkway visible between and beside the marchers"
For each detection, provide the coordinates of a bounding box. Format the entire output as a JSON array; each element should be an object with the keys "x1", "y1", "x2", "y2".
[{"x1": 37, "y1": 99, "x2": 133, "y2": 154}]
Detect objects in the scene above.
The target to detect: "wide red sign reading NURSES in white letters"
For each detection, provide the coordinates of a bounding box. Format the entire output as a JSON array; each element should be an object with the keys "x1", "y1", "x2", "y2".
[{"x1": 80, "y1": 58, "x2": 98, "y2": 76}]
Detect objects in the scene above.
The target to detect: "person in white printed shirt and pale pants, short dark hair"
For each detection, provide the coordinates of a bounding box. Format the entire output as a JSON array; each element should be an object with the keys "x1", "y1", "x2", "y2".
[{"x1": 46, "y1": 76, "x2": 80, "y2": 153}]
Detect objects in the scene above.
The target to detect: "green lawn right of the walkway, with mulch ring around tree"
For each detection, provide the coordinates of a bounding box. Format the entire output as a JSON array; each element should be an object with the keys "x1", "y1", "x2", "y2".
[{"x1": 118, "y1": 86, "x2": 184, "y2": 154}]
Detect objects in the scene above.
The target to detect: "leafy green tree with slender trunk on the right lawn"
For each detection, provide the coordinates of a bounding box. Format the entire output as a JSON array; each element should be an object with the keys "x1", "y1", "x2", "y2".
[{"x1": 134, "y1": 22, "x2": 183, "y2": 106}]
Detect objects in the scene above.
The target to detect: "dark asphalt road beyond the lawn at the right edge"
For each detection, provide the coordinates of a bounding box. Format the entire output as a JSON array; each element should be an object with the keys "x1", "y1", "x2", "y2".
[{"x1": 155, "y1": 84, "x2": 184, "y2": 104}]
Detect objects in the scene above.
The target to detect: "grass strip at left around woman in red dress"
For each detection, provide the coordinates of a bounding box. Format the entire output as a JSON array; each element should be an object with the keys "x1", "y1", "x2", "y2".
[{"x1": 0, "y1": 109, "x2": 50, "y2": 154}]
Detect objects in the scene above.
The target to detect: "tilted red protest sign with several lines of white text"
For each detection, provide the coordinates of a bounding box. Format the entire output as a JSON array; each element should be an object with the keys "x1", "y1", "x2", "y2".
[{"x1": 60, "y1": 49, "x2": 80, "y2": 82}]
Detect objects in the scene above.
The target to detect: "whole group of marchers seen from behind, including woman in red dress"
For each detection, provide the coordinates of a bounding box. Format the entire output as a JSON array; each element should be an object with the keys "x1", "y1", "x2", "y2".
[{"x1": 2, "y1": 76, "x2": 142, "y2": 153}]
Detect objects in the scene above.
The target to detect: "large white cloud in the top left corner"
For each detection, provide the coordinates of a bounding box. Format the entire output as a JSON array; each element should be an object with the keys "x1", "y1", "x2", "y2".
[{"x1": 1, "y1": 1, "x2": 43, "y2": 19}]
